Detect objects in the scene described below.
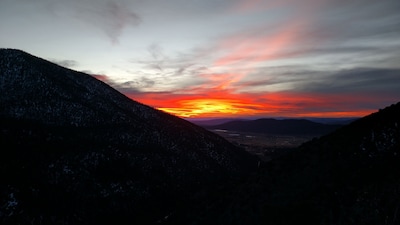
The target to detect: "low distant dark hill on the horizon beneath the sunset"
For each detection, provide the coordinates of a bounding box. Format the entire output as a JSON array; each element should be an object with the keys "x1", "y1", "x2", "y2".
[{"x1": 204, "y1": 118, "x2": 341, "y2": 135}]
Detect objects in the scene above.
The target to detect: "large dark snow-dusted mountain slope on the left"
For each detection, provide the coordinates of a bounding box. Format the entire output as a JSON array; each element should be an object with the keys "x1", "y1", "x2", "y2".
[{"x1": 0, "y1": 49, "x2": 257, "y2": 225}]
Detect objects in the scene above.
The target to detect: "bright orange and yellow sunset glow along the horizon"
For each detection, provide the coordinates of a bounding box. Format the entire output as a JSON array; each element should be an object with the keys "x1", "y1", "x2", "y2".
[{"x1": 128, "y1": 92, "x2": 377, "y2": 118}]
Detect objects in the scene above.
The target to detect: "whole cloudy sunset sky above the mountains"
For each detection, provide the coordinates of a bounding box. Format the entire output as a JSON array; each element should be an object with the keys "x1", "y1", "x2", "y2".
[{"x1": 0, "y1": 0, "x2": 400, "y2": 118}]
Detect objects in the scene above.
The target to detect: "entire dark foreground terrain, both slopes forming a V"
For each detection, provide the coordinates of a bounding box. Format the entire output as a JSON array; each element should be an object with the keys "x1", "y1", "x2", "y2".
[{"x1": 0, "y1": 49, "x2": 400, "y2": 225}]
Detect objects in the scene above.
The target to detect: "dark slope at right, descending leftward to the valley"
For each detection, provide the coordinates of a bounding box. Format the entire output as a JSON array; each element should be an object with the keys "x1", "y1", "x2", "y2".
[{"x1": 170, "y1": 102, "x2": 400, "y2": 225}]
